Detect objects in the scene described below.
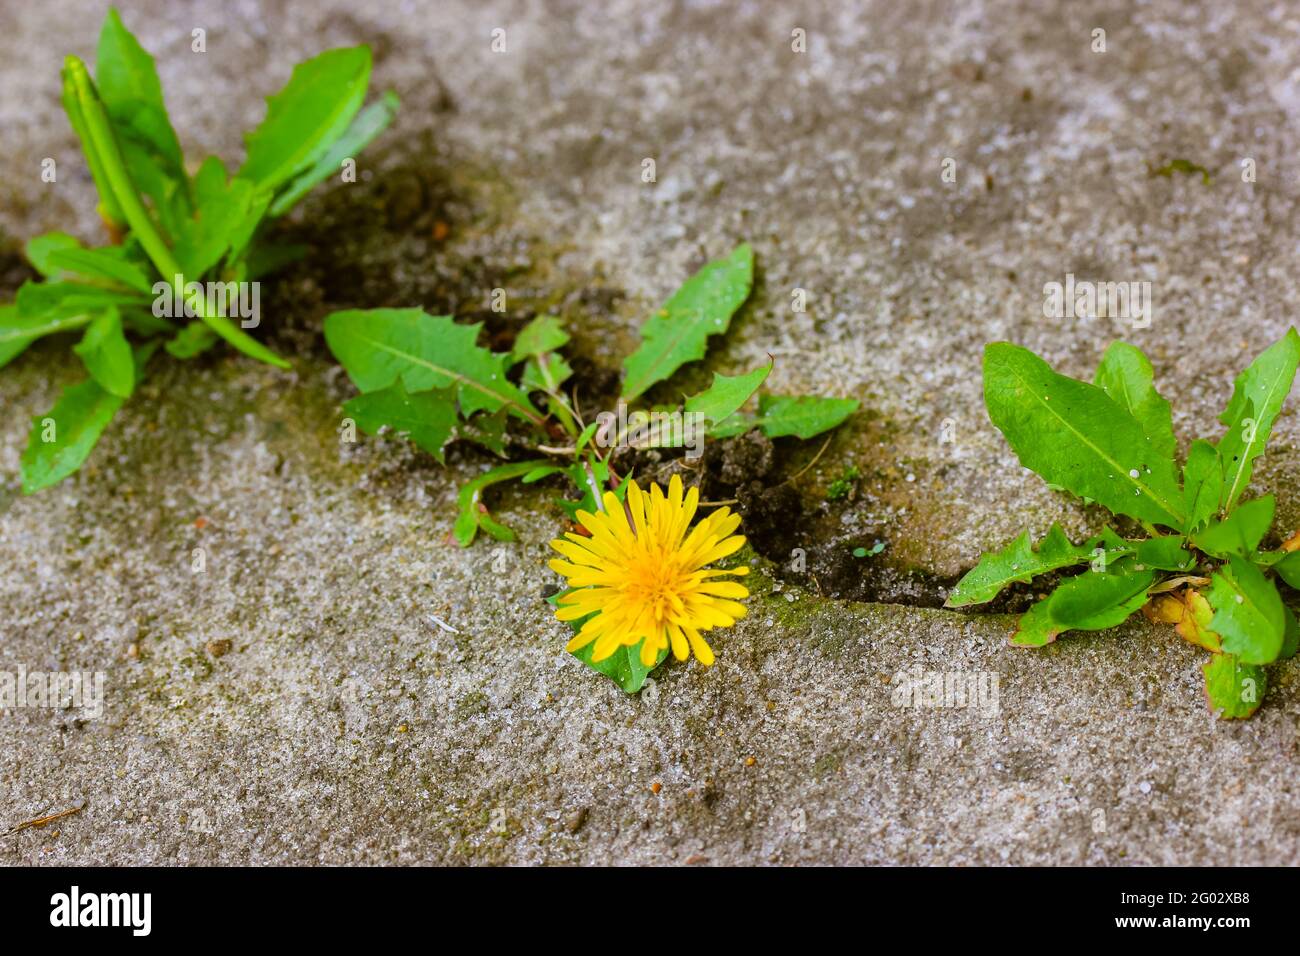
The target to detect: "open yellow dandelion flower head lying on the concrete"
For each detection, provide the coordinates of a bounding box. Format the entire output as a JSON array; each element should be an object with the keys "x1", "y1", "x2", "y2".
[{"x1": 550, "y1": 475, "x2": 749, "y2": 667}]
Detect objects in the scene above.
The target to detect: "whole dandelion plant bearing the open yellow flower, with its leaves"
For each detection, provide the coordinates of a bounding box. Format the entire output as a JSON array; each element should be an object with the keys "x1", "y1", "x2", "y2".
[{"x1": 325, "y1": 245, "x2": 857, "y2": 693}]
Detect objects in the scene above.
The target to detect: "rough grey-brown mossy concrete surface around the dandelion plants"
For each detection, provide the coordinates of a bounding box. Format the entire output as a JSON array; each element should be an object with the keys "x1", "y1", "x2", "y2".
[{"x1": 0, "y1": 0, "x2": 1300, "y2": 864}]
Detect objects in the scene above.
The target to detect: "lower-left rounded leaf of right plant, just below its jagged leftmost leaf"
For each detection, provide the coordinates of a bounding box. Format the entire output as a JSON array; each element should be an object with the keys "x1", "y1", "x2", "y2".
[{"x1": 1011, "y1": 571, "x2": 1156, "y2": 648}]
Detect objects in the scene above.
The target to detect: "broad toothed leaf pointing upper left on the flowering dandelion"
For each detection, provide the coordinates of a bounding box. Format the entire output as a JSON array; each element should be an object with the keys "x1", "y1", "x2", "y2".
[{"x1": 325, "y1": 308, "x2": 542, "y2": 424}]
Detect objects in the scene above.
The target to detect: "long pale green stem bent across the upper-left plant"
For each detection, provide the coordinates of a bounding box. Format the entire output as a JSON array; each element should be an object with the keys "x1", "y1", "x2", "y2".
[{"x1": 65, "y1": 56, "x2": 290, "y2": 368}]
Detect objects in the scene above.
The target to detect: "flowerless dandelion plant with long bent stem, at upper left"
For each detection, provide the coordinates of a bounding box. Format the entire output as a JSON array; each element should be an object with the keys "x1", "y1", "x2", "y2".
[{"x1": 0, "y1": 8, "x2": 398, "y2": 494}]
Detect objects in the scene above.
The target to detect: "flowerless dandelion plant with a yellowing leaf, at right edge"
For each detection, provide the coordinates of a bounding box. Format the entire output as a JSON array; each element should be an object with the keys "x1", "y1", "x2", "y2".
[{"x1": 948, "y1": 329, "x2": 1300, "y2": 718}]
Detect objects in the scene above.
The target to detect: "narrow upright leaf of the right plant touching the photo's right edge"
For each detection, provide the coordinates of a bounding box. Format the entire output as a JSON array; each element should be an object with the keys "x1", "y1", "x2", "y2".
[{"x1": 1218, "y1": 328, "x2": 1300, "y2": 511}]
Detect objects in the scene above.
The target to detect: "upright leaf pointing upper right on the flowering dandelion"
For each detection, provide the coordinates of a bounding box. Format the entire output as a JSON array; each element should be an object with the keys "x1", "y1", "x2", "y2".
[{"x1": 623, "y1": 243, "x2": 754, "y2": 401}]
